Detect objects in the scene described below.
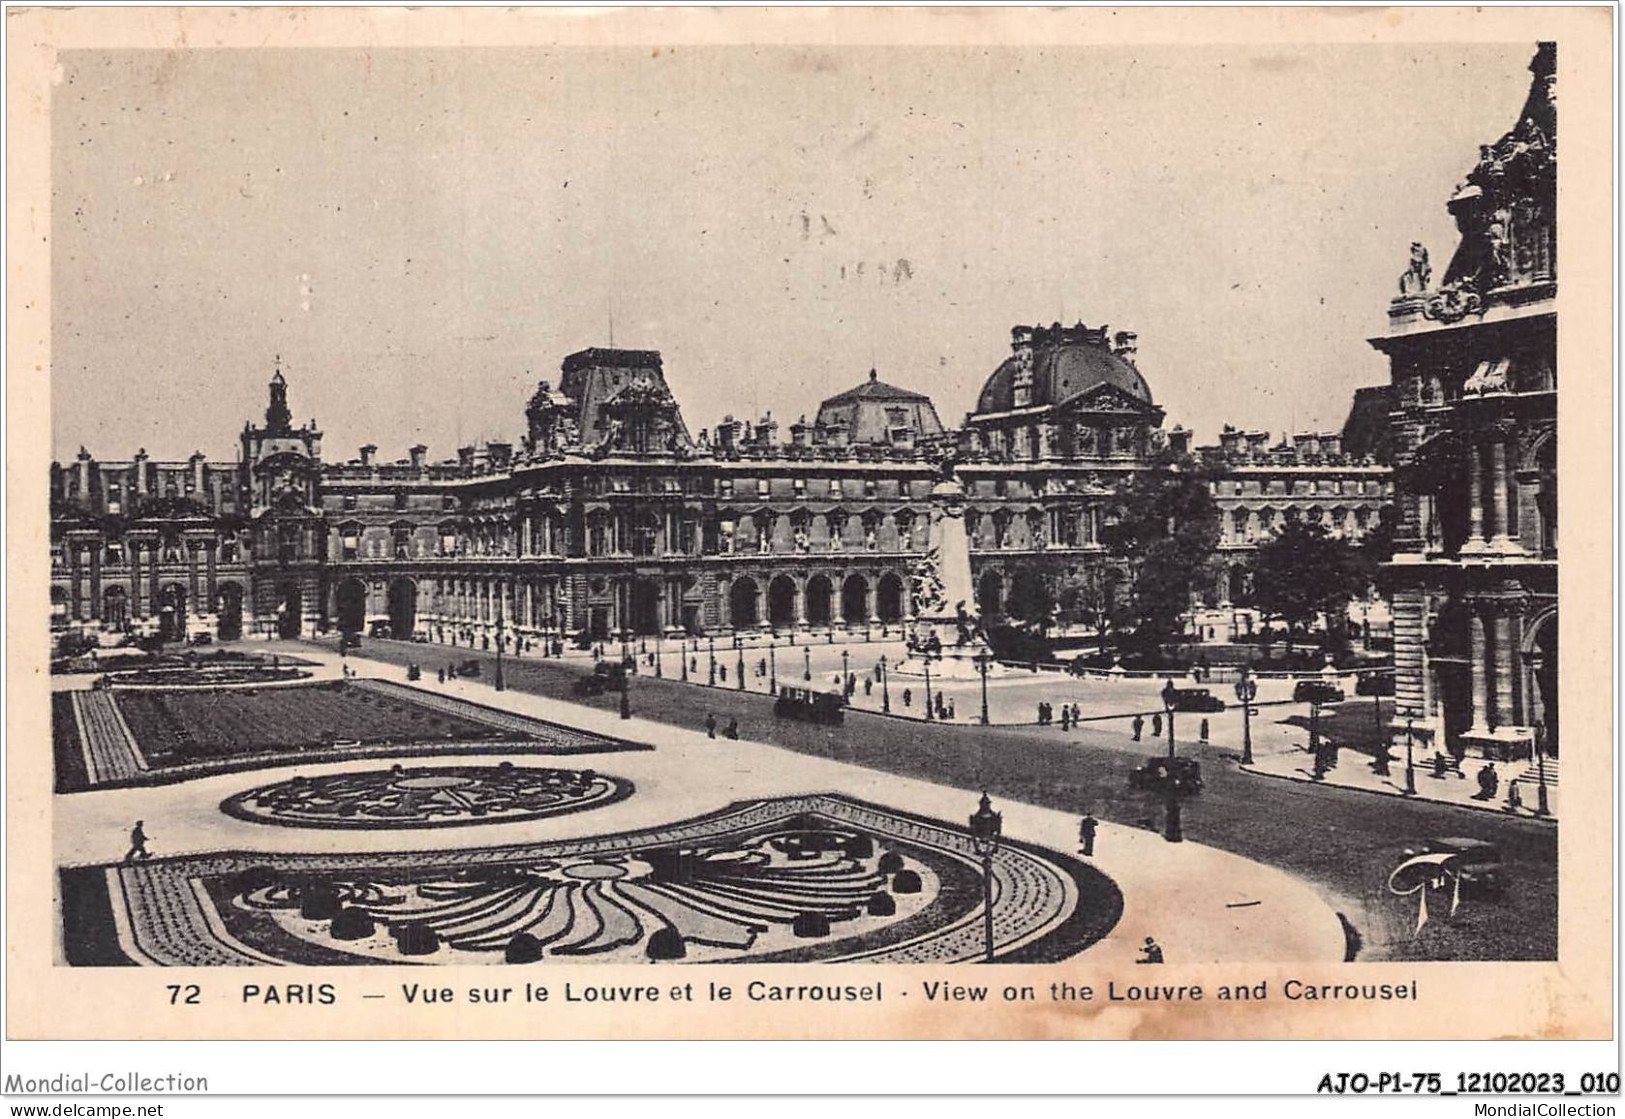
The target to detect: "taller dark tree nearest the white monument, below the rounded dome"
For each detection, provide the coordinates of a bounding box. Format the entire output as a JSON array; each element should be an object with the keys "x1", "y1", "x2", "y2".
[{"x1": 1102, "y1": 460, "x2": 1219, "y2": 650}]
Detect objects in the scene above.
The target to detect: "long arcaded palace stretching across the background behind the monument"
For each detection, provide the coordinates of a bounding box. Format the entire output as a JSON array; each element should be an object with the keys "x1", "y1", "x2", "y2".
[{"x1": 52, "y1": 323, "x2": 1389, "y2": 646}]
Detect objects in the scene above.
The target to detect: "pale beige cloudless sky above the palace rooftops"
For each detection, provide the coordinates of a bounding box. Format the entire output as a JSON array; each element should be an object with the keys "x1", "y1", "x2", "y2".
[{"x1": 52, "y1": 42, "x2": 1534, "y2": 461}]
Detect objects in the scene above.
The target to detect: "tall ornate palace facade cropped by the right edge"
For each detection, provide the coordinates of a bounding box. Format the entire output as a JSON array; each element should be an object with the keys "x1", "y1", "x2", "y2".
[{"x1": 1372, "y1": 42, "x2": 1557, "y2": 757}]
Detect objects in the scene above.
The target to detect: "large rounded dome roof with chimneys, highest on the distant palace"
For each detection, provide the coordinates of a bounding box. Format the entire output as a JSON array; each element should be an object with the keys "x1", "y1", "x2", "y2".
[{"x1": 977, "y1": 323, "x2": 1152, "y2": 413}]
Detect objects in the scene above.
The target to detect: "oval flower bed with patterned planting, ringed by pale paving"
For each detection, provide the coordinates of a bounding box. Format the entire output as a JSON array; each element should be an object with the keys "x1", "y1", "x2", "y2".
[{"x1": 219, "y1": 762, "x2": 632, "y2": 828}]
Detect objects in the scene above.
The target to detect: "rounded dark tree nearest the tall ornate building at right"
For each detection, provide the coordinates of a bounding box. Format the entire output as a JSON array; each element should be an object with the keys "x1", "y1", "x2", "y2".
[{"x1": 1253, "y1": 521, "x2": 1367, "y2": 642}]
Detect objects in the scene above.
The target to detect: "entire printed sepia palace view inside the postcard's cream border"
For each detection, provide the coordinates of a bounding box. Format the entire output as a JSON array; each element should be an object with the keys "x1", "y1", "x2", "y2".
[{"x1": 39, "y1": 41, "x2": 1565, "y2": 971}]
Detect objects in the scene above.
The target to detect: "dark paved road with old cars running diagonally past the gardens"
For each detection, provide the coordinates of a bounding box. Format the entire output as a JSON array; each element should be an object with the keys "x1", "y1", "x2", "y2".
[{"x1": 320, "y1": 638, "x2": 1557, "y2": 960}]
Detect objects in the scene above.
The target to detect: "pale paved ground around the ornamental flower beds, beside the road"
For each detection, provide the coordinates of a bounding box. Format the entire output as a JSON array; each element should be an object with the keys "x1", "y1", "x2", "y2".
[{"x1": 55, "y1": 643, "x2": 1346, "y2": 963}]
